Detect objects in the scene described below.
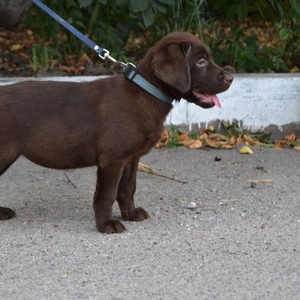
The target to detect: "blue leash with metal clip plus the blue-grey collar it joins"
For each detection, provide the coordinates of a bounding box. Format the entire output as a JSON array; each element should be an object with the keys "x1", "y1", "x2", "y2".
[{"x1": 31, "y1": 0, "x2": 173, "y2": 104}]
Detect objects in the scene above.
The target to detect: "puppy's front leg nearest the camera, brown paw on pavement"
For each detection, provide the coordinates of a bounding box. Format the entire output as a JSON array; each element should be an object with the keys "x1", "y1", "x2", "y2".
[{"x1": 93, "y1": 165, "x2": 125, "y2": 233}]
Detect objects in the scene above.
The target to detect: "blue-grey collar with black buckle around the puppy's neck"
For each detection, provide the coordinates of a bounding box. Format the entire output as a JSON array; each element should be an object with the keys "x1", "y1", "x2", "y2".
[{"x1": 124, "y1": 63, "x2": 174, "y2": 104}]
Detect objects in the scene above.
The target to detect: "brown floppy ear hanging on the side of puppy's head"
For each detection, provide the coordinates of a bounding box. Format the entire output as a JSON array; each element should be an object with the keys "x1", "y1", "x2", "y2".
[{"x1": 151, "y1": 44, "x2": 191, "y2": 94}]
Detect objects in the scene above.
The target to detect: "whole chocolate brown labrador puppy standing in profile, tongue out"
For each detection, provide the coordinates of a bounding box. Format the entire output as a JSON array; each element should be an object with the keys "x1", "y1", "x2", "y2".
[{"x1": 0, "y1": 32, "x2": 233, "y2": 233}]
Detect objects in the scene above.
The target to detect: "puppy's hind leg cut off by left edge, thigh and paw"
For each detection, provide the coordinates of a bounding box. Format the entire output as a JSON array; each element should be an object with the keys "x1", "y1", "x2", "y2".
[{"x1": 0, "y1": 145, "x2": 20, "y2": 221}]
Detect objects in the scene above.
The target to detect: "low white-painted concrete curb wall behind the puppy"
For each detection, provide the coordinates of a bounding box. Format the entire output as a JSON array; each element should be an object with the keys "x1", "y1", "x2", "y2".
[{"x1": 0, "y1": 73, "x2": 300, "y2": 132}]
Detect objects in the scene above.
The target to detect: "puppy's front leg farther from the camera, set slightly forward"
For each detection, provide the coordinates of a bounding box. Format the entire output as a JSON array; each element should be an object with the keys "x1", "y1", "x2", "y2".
[{"x1": 117, "y1": 159, "x2": 149, "y2": 221}]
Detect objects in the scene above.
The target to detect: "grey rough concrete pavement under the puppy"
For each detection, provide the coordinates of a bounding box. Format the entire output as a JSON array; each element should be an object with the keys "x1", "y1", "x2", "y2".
[{"x1": 0, "y1": 148, "x2": 300, "y2": 300}]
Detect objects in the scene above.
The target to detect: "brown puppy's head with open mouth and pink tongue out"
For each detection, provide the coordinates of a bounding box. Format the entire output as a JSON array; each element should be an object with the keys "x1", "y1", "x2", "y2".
[{"x1": 151, "y1": 32, "x2": 233, "y2": 108}]
